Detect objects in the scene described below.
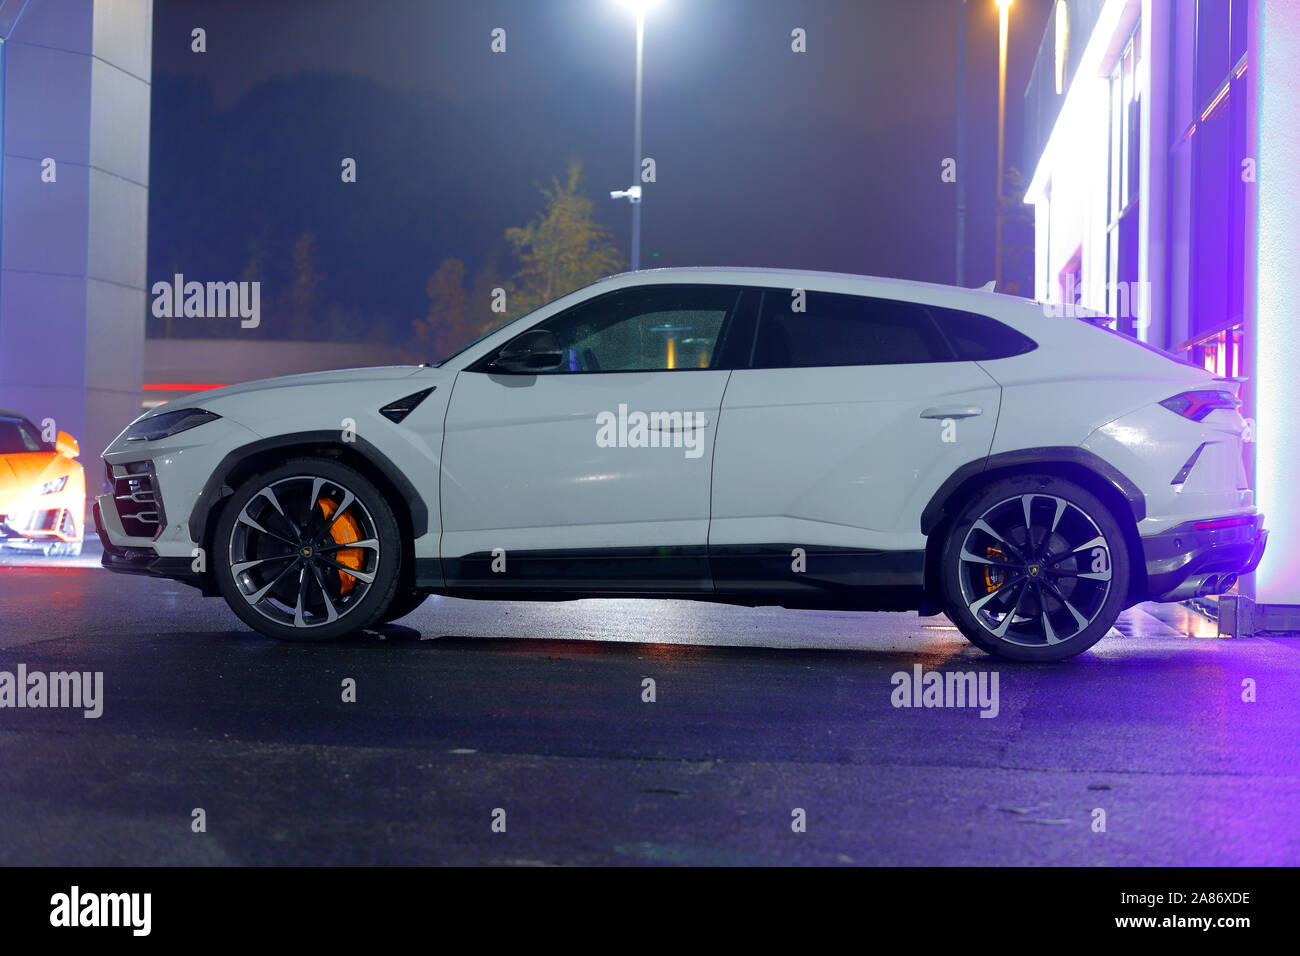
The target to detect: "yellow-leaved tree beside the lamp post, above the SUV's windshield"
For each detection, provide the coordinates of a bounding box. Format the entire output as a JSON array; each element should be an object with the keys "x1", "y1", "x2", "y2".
[{"x1": 506, "y1": 159, "x2": 623, "y2": 317}]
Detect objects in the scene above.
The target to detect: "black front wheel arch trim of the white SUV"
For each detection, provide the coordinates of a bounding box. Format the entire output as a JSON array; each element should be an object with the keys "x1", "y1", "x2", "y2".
[{"x1": 189, "y1": 431, "x2": 429, "y2": 582}]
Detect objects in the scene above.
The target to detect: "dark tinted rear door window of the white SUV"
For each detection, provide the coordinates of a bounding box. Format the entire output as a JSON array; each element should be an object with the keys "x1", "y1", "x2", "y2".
[{"x1": 750, "y1": 289, "x2": 953, "y2": 368}]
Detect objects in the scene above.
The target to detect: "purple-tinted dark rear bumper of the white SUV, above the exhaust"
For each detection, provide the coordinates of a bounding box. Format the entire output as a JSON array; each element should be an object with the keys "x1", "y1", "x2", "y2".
[{"x1": 1141, "y1": 515, "x2": 1269, "y2": 601}]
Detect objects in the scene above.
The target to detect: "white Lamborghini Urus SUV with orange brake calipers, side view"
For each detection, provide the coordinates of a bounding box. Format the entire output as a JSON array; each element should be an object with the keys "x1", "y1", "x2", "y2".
[{"x1": 94, "y1": 269, "x2": 1266, "y2": 661}]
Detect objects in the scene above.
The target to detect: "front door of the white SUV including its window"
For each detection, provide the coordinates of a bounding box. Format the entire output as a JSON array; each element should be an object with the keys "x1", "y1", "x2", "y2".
[{"x1": 441, "y1": 285, "x2": 738, "y2": 593}]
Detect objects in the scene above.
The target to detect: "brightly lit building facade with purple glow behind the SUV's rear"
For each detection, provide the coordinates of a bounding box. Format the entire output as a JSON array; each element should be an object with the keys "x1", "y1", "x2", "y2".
[{"x1": 1024, "y1": 0, "x2": 1300, "y2": 633}]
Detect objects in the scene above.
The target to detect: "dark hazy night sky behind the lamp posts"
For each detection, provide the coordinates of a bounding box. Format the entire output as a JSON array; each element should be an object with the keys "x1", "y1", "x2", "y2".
[{"x1": 148, "y1": 0, "x2": 1050, "y2": 338}]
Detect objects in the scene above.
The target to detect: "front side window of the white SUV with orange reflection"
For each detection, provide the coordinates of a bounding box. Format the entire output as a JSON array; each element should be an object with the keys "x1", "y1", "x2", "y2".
[{"x1": 517, "y1": 285, "x2": 740, "y2": 375}]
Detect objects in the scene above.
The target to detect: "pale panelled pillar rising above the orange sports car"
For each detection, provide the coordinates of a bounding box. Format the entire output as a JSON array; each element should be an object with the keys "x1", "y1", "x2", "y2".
[{"x1": 0, "y1": 0, "x2": 153, "y2": 494}]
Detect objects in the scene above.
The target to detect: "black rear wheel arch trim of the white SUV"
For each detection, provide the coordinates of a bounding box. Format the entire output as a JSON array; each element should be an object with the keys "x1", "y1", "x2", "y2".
[{"x1": 920, "y1": 445, "x2": 1147, "y2": 609}]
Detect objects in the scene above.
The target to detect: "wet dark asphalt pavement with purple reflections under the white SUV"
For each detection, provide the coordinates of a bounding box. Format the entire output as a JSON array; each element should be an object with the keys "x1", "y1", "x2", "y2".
[{"x1": 0, "y1": 561, "x2": 1300, "y2": 865}]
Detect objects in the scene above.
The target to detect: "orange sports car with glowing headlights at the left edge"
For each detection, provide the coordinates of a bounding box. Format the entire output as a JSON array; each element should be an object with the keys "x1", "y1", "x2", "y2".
[{"x1": 0, "y1": 408, "x2": 86, "y2": 554}]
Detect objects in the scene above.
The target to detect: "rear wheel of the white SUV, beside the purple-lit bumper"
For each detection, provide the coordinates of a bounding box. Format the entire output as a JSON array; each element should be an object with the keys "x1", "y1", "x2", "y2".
[{"x1": 940, "y1": 473, "x2": 1131, "y2": 662}]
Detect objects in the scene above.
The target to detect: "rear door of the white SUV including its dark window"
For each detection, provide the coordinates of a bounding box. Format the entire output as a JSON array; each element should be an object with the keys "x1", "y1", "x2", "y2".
[{"x1": 709, "y1": 289, "x2": 1000, "y2": 591}]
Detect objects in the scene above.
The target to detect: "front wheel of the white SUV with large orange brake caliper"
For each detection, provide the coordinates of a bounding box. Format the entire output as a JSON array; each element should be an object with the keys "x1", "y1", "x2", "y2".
[{"x1": 209, "y1": 458, "x2": 402, "y2": 641}]
